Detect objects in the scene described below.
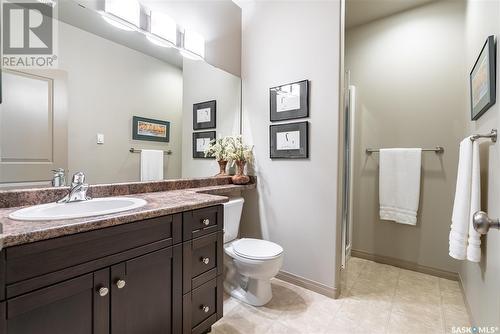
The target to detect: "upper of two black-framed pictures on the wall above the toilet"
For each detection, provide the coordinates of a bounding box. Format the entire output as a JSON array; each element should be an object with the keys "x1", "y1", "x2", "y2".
[{"x1": 269, "y1": 80, "x2": 309, "y2": 122}]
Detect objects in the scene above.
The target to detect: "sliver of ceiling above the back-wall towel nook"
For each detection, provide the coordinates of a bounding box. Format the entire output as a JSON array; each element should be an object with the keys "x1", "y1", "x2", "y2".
[{"x1": 346, "y1": 0, "x2": 436, "y2": 28}]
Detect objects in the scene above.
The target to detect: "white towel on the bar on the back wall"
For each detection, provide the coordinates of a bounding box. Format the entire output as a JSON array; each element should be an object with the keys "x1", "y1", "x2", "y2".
[{"x1": 379, "y1": 148, "x2": 422, "y2": 225}]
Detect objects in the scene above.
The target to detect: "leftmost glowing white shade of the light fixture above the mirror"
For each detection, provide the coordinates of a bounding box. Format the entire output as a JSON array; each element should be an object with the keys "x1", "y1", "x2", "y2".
[{"x1": 100, "y1": 0, "x2": 141, "y2": 31}]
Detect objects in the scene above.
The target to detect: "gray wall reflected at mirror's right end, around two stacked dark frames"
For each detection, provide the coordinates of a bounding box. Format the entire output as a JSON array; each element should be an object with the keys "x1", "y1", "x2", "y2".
[{"x1": 182, "y1": 59, "x2": 241, "y2": 177}]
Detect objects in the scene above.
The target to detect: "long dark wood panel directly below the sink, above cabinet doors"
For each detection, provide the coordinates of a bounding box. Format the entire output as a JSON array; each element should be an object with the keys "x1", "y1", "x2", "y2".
[{"x1": 5, "y1": 214, "x2": 182, "y2": 284}]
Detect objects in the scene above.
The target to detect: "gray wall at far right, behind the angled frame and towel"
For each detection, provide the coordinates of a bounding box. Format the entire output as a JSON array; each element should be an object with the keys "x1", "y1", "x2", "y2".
[{"x1": 460, "y1": 1, "x2": 500, "y2": 326}]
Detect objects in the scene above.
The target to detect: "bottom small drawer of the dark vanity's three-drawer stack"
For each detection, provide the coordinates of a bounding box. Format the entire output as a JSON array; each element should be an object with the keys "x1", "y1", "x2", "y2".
[{"x1": 183, "y1": 275, "x2": 223, "y2": 334}]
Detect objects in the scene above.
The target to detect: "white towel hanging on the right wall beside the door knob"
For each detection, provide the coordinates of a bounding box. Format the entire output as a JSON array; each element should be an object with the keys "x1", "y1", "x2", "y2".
[{"x1": 449, "y1": 137, "x2": 481, "y2": 262}]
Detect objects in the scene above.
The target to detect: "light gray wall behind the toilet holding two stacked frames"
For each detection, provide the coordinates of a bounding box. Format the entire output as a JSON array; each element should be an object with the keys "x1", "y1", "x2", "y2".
[{"x1": 241, "y1": 1, "x2": 340, "y2": 288}]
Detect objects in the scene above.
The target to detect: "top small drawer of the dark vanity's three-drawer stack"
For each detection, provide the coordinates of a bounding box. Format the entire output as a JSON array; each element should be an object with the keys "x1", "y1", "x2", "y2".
[{"x1": 183, "y1": 205, "x2": 223, "y2": 240}]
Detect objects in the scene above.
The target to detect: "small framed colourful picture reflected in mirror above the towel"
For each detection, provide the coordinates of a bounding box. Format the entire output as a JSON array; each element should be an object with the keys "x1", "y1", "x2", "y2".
[{"x1": 132, "y1": 116, "x2": 170, "y2": 143}]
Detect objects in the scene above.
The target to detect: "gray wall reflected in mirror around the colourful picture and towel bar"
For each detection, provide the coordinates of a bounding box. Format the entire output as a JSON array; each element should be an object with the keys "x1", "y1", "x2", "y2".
[{"x1": 59, "y1": 22, "x2": 182, "y2": 183}]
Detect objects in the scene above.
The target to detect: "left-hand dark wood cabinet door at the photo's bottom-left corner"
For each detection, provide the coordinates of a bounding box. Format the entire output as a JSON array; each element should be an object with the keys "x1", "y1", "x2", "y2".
[{"x1": 2, "y1": 269, "x2": 109, "y2": 334}]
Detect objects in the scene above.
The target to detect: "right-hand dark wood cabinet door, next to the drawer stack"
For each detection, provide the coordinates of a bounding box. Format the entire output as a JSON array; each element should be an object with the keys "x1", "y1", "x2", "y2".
[{"x1": 111, "y1": 245, "x2": 182, "y2": 334}]
